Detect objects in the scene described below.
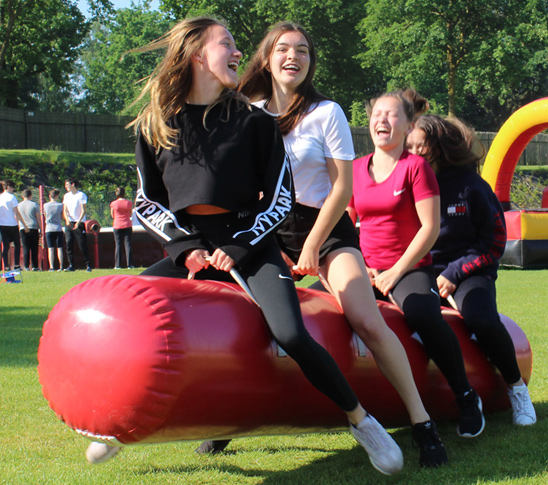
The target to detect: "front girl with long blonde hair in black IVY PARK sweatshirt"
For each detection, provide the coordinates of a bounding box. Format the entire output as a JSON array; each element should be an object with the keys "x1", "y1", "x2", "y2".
[{"x1": 86, "y1": 17, "x2": 403, "y2": 474}]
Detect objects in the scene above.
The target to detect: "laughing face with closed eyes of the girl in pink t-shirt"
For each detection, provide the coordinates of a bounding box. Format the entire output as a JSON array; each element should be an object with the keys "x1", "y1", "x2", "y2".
[{"x1": 369, "y1": 96, "x2": 413, "y2": 151}]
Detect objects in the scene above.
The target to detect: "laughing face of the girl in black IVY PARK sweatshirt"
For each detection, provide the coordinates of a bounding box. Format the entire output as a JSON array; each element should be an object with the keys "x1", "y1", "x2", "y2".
[{"x1": 196, "y1": 25, "x2": 242, "y2": 90}]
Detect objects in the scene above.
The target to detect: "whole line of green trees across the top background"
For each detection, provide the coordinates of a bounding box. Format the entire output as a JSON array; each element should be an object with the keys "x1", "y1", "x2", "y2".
[{"x1": 0, "y1": 0, "x2": 548, "y2": 131}]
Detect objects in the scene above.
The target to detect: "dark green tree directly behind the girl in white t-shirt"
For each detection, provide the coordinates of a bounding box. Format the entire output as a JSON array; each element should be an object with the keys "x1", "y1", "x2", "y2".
[{"x1": 160, "y1": 0, "x2": 380, "y2": 115}]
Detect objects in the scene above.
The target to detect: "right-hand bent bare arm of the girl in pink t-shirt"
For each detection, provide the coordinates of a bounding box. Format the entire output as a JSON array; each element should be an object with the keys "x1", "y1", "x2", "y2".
[{"x1": 375, "y1": 196, "x2": 440, "y2": 295}]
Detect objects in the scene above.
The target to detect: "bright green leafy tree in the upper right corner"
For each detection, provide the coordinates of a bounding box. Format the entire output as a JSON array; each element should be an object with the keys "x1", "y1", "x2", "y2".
[{"x1": 360, "y1": 0, "x2": 547, "y2": 125}]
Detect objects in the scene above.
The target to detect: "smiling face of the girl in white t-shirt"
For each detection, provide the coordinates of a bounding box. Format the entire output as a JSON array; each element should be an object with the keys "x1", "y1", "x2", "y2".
[{"x1": 268, "y1": 31, "x2": 310, "y2": 92}]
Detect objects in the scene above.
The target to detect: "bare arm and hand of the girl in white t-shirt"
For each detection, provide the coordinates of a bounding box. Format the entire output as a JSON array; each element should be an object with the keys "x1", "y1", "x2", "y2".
[{"x1": 295, "y1": 158, "x2": 352, "y2": 276}]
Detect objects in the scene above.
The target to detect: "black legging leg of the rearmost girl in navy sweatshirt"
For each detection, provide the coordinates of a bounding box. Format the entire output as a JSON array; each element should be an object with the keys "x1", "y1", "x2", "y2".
[{"x1": 454, "y1": 275, "x2": 521, "y2": 384}]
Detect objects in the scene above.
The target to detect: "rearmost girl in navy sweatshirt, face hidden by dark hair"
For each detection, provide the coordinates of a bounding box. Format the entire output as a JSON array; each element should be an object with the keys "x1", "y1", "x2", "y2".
[{"x1": 407, "y1": 115, "x2": 536, "y2": 426}]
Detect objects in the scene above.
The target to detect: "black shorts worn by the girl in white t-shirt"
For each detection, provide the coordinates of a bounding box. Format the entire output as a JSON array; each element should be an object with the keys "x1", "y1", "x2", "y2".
[{"x1": 276, "y1": 204, "x2": 360, "y2": 264}]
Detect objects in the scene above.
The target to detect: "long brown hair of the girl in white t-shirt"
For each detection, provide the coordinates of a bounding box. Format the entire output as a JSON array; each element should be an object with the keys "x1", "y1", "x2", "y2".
[{"x1": 239, "y1": 22, "x2": 328, "y2": 135}]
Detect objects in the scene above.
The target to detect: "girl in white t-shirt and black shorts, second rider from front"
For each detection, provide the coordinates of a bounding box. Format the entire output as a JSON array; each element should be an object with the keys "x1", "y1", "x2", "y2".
[{"x1": 197, "y1": 22, "x2": 447, "y2": 467}]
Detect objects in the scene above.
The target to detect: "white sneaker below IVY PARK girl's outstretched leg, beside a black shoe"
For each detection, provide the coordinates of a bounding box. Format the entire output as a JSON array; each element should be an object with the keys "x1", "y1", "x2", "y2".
[{"x1": 350, "y1": 414, "x2": 403, "y2": 475}]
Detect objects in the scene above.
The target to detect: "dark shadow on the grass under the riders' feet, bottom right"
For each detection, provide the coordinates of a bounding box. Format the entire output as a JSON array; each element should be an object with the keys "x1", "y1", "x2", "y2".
[{"x1": 124, "y1": 403, "x2": 548, "y2": 485}]
